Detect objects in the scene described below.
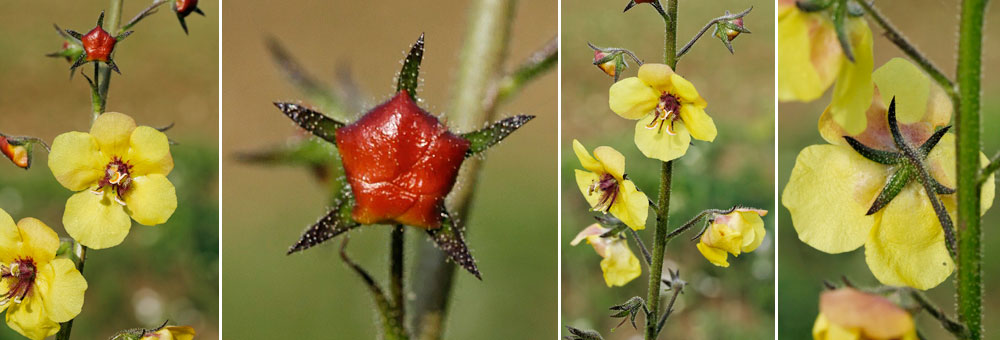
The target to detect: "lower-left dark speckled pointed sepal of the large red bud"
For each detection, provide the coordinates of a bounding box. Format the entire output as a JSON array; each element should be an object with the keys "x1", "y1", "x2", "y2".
[{"x1": 286, "y1": 186, "x2": 361, "y2": 255}]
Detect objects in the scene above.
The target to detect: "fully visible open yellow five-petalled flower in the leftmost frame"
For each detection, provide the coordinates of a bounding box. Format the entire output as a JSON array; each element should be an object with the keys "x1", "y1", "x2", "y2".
[{"x1": 49, "y1": 112, "x2": 177, "y2": 249}]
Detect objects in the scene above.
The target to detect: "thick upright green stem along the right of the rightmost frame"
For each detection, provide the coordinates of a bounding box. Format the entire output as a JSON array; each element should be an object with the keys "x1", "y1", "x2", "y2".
[{"x1": 955, "y1": 0, "x2": 987, "y2": 340}]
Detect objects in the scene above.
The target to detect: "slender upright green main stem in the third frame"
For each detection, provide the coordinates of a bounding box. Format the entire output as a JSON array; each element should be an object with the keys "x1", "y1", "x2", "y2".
[{"x1": 645, "y1": 0, "x2": 677, "y2": 340}]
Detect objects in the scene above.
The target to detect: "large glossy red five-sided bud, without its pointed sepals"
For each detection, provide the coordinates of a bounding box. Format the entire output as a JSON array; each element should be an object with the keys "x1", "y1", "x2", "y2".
[{"x1": 337, "y1": 90, "x2": 469, "y2": 229}]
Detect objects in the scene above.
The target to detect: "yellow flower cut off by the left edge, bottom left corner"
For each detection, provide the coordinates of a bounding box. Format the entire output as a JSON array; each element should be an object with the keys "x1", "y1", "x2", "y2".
[{"x1": 0, "y1": 209, "x2": 87, "y2": 340}]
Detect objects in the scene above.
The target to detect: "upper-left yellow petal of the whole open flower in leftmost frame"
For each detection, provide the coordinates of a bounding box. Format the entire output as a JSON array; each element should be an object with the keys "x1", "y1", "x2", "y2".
[{"x1": 49, "y1": 131, "x2": 106, "y2": 191}]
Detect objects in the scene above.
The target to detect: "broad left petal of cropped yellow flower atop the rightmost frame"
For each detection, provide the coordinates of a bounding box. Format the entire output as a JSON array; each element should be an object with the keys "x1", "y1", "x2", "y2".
[{"x1": 778, "y1": 9, "x2": 840, "y2": 102}]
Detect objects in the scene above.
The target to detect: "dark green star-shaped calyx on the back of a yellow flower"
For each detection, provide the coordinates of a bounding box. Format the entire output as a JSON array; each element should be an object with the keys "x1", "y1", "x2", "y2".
[{"x1": 844, "y1": 97, "x2": 955, "y2": 215}]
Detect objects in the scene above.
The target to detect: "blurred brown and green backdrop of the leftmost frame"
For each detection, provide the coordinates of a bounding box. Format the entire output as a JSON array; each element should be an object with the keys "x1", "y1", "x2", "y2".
[{"x1": 0, "y1": 0, "x2": 219, "y2": 339}]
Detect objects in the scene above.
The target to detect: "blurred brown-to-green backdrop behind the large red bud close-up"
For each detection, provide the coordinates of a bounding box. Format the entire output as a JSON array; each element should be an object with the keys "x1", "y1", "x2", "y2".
[{"x1": 222, "y1": 0, "x2": 558, "y2": 339}]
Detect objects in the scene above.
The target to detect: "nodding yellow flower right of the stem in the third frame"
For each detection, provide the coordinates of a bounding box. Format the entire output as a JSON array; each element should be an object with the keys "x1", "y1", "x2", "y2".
[{"x1": 697, "y1": 209, "x2": 767, "y2": 267}]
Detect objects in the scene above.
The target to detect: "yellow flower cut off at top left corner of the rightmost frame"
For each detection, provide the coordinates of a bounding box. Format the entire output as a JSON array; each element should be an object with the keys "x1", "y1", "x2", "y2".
[{"x1": 778, "y1": 0, "x2": 874, "y2": 134}]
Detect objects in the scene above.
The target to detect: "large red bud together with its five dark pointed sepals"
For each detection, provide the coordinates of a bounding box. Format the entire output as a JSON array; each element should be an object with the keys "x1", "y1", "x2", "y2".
[{"x1": 275, "y1": 34, "x2": 534, "y2": 277}]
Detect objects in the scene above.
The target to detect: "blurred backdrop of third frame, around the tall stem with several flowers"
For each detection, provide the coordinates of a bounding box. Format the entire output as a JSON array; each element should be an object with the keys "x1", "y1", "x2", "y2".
[{"x1": 560, "y1": 0, "x2": 774, "y2": 339}]
